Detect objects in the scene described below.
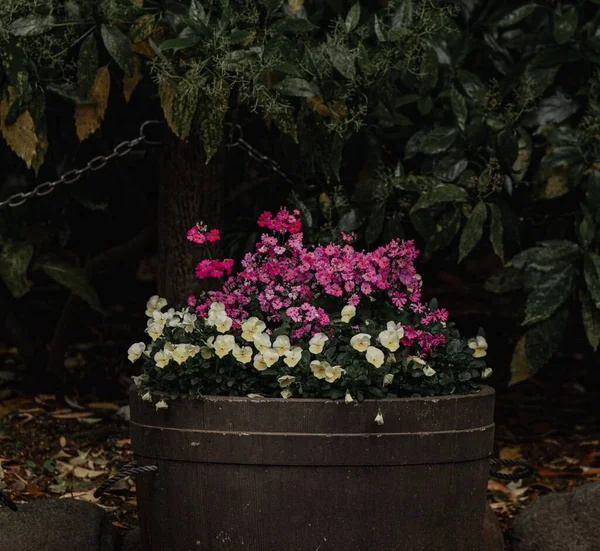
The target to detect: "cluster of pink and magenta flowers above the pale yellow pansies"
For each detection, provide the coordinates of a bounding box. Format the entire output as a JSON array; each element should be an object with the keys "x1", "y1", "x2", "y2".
[{"x1": 188, "y1": 209, "x2": 448, "y2": 354}]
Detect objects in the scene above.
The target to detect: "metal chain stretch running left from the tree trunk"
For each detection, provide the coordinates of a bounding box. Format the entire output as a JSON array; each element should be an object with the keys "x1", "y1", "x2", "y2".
[{"x1": 0, "y1": 120, "x2": 162, "y2": 209}]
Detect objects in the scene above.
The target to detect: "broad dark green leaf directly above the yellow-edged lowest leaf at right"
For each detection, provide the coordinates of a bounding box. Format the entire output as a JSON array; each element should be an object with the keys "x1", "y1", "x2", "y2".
[{"x1": 523, "y1": 266, "x2": 575, "y2": 325}]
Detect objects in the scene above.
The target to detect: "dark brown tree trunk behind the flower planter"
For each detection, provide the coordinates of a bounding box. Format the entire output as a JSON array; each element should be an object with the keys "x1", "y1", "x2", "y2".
[{"x1": 158, "y1": 129, "x2": 225, "y2": 305}]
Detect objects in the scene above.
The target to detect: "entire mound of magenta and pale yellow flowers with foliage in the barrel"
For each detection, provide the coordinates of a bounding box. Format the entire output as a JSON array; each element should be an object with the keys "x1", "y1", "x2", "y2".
[{"x1": 128, "y1": 209, "x2": 491, "y2": 422}]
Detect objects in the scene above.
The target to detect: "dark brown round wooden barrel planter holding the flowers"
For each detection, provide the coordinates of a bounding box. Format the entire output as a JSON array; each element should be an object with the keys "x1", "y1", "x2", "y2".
[{"x1": 131, "y1": 387, "x2": 494, "y2": 551}]
